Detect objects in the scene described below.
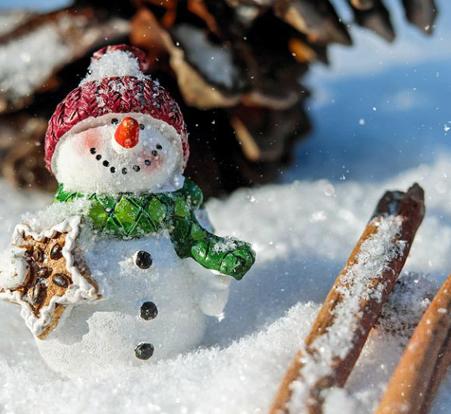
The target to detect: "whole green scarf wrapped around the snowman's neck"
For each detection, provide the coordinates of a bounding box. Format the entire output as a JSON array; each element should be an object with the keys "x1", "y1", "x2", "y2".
[{"x1": 55, "y1": 179, "x2": 255, "y2": 279}]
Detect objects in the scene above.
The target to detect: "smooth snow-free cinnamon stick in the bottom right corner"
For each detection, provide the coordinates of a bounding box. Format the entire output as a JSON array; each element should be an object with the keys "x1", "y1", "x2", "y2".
[{"x1": 376, "y1": 276, "x2": 451, "y2": 414}]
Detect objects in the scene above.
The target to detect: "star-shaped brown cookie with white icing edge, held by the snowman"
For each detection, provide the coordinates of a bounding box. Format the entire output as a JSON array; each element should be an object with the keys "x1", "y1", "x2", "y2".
[{"x1": 0, "y1": 216, "x2": 100, "y2": 339}]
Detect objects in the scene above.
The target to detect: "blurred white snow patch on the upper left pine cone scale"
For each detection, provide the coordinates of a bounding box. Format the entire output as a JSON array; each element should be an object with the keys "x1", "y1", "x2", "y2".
[{"x1": 0, "y1": 24, "x2": 70, "y2": 99}]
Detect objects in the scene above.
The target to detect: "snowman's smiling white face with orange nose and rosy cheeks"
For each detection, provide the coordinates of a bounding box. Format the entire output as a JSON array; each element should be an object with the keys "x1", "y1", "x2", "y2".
[{"x1": 52, "y1": 113, "x2": 183, "y2": 194}]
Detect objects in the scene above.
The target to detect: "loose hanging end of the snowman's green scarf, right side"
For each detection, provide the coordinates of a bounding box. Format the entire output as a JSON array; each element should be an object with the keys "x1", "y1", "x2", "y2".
[{"x1": 172, "y1": 213, "x2": 255, "y2": 280}]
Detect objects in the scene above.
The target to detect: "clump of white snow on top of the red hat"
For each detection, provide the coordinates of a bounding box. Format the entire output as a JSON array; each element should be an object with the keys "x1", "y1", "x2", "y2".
[{"x1": 81, "y1": 50, "x2": 146, "y2": 83}]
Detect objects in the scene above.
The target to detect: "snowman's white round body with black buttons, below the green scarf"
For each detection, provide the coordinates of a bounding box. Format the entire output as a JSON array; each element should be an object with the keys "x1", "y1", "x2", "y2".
[{"x1": 37, "y1": 228, "x2": 228, "y2": 375}]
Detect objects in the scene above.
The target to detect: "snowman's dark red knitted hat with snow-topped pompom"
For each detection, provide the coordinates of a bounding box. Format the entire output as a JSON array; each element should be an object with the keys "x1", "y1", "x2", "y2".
[{"x1": 45, "y1": 45, "x2": 189, "y2": 171}]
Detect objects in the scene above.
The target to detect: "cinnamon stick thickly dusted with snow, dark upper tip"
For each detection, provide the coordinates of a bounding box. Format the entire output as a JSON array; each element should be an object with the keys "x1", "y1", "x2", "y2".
[{"x1": 270, "y1": 184, "x2": 425, "y2": 414}]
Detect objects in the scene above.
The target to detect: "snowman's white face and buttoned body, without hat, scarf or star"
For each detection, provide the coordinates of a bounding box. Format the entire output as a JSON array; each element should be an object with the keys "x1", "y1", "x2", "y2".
[{"x1": 31, "y1": 103, "x2": 230, "y2": 376}]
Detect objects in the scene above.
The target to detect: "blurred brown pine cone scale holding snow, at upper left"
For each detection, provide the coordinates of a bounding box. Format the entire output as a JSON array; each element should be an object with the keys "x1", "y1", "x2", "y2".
[{"x1": 0, "y1": 7, "x2": 129, "y2": 113}]
